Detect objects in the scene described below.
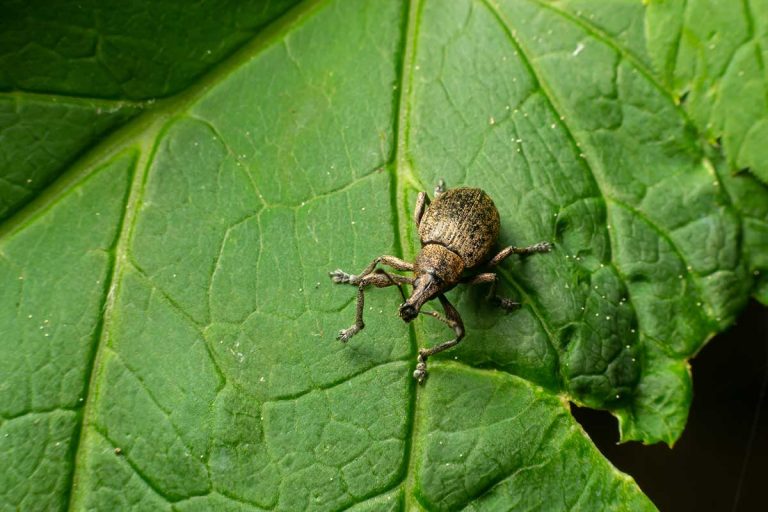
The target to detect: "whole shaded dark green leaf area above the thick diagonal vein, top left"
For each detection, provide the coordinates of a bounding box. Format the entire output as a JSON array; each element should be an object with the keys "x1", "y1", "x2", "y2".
[{"x1": 0, "y1": 0, "x2": 304, "y2": 220}]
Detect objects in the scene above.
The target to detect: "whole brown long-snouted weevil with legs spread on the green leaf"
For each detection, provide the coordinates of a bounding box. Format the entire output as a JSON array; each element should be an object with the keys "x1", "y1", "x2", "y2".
[{"x1": 329, "y1": 180, "x2": 552, "y2": 383}]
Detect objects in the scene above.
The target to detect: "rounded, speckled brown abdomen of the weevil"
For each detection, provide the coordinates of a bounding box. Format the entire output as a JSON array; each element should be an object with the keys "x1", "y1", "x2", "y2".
[{"x1": 419, "y1": 188, "x2": 500, "y2": 268}]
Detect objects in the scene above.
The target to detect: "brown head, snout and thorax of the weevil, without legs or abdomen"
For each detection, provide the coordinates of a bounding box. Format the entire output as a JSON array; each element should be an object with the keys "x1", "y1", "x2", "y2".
[{"x1": 399, "y1": 244, "x2": 464, "y2": 322}]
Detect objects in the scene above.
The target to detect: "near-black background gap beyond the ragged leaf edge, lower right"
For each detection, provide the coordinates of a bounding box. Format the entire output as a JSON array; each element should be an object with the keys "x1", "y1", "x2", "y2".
[{"x1": 572, "y1": 301, "x2": 768, "y2": 512}]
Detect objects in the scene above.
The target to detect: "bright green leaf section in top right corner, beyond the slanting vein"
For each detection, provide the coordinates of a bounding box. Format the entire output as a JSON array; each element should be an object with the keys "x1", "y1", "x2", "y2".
[{"x1": 556, "y1": 0, "x2": 768, "y2": 183}]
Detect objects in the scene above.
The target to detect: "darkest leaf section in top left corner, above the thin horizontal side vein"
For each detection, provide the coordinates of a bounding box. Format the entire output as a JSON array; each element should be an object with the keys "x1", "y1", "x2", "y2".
[{"x1": 0, "y1": 0, "x2": 296, "y2": 100}]
